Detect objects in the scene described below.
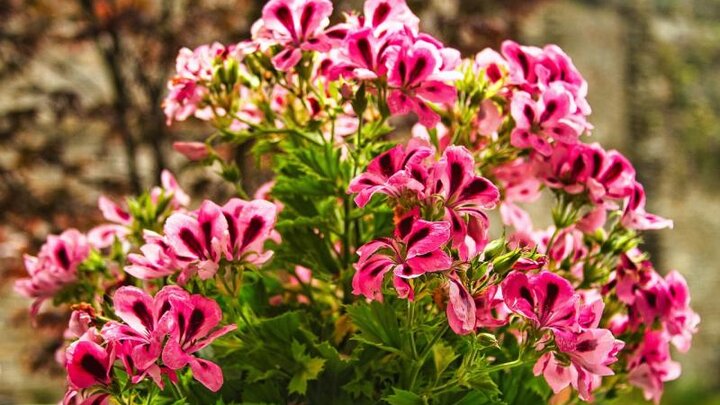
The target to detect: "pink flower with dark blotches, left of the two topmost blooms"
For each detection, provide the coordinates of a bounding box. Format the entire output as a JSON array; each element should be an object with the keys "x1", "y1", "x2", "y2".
[{"x1": 262, "y1": 0, "x2": 333, "y2": 71}]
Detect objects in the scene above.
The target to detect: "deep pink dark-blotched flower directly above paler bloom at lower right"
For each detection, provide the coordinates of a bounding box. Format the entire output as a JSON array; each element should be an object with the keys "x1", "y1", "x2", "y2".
[{"x1": 502, "y1": 271, "x2": 579, "y2": 330}]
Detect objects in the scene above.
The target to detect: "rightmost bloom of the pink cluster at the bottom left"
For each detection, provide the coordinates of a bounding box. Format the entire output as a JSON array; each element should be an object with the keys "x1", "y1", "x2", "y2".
[{"x1": 162, "y1": 291, "x2": 237, "y2": 392}]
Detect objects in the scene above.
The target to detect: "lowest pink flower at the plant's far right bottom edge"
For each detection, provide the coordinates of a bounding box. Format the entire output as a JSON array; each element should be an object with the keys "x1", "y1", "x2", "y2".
[{"x1": 628, "y1": 331, "x2": 680, "y2": 404}]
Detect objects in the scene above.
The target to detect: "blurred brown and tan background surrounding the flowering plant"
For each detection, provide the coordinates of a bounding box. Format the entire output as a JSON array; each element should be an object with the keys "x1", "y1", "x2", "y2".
[{"x1": 0, "y1": 0, "x2": 720, "y2": 405}]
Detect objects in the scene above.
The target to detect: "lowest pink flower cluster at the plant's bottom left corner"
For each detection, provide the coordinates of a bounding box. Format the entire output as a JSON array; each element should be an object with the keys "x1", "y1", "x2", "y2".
[{"x1": 65, "y1": 286, "x2": 236, "y2": 391}]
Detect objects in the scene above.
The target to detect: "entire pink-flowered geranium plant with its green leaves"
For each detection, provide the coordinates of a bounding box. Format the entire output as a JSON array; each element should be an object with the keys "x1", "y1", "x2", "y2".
[{"x1": 16, "y1": 0, "x2": 699, "y2": 404}]
